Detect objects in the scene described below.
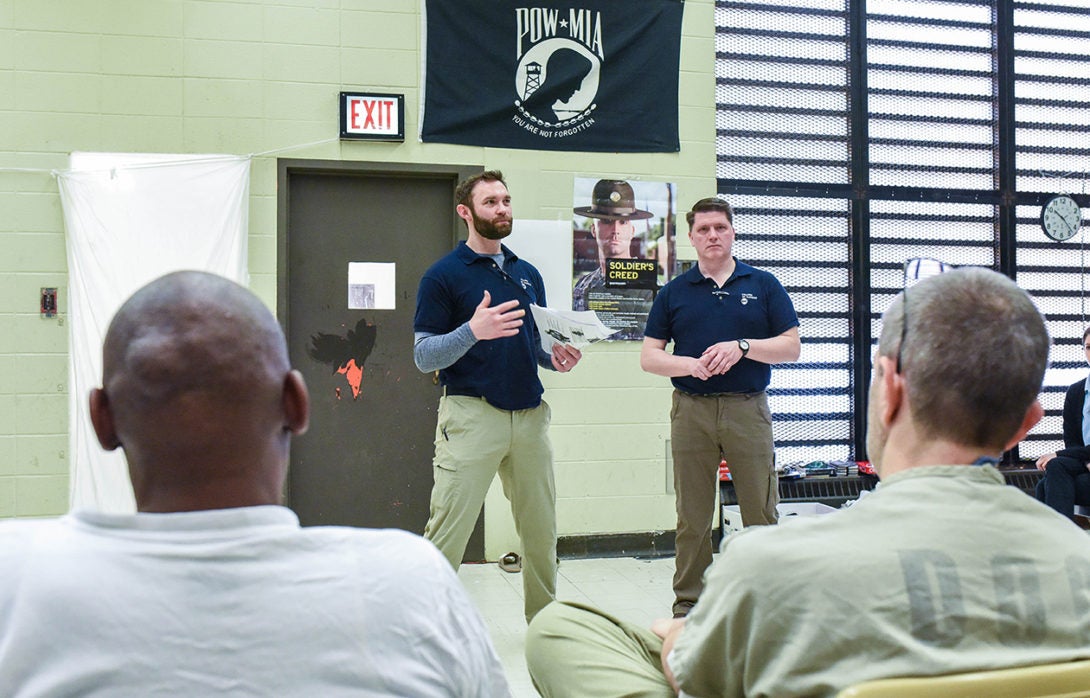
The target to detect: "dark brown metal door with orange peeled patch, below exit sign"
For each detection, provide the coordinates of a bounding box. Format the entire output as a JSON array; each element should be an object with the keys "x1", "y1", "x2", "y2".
[{"x1": 278, "y1": 160, "x2": 483, "y2": 559}]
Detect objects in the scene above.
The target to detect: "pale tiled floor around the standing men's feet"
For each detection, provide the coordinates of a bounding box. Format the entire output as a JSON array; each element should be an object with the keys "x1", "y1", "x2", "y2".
[{"x1": 458, "y1": 557, "x2": 674, "y2": 698}]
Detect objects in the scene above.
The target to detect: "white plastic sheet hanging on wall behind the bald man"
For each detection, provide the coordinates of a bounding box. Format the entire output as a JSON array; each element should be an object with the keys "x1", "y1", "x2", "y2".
[{"x1": 58, "y1": 153, "x2": 250, "y2": 513}]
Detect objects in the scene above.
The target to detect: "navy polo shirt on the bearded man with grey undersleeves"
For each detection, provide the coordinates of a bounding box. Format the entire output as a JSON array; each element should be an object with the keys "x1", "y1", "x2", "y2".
[{"x1": 413, "y1": 241, "x2": 546, "y2": 410}]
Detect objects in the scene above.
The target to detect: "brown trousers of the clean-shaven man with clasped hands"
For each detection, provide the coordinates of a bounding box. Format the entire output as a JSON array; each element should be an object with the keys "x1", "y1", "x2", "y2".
[{"x1": 670, "y1": 390, "x2": 779, "y2": 613}]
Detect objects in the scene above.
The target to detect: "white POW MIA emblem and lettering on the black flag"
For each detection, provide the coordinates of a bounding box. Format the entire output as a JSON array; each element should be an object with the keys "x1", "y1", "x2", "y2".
[{"x1": 511, "y1": 8, "x2": 605, "y2": 139}]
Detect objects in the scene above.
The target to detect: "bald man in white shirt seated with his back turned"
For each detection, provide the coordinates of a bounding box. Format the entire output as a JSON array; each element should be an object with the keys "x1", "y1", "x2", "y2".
[{"x1": 0, "y1": 272, "x2": 509, "y2": 698}]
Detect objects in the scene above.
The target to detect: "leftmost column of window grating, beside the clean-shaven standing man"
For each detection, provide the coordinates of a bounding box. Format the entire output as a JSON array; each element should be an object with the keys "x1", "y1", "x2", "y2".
[{"x1": 716, "y1": 0, "x2": 853, "y2": 462}]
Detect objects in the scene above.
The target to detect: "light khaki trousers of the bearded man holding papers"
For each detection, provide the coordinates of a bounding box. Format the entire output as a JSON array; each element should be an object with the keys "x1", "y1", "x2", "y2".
[{"x1": 424, "y1": 395, "x2": 556, "y2": 622}]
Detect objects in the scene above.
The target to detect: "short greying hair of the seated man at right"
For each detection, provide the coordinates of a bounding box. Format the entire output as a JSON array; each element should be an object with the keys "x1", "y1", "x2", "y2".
[{"x1": 879, "y1": 267, "x2": 1050, "y2": 452}]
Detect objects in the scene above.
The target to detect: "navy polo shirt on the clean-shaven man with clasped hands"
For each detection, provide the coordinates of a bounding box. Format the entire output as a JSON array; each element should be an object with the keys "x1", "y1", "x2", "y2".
[{"x1": 644, "y1": 260, "x2": 799, "y2": 395}]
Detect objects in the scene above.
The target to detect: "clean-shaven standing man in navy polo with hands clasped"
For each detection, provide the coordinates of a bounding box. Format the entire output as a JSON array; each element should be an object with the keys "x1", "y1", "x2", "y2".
[{"x1": 640, "y1": 197, "x2": 801, "y2": 617}]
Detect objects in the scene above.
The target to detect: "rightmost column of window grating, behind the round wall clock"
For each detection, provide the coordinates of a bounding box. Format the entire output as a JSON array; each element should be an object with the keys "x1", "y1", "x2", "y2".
[{"x1": 1014, "y1": 2, "x2": 1090, "y2": 455}]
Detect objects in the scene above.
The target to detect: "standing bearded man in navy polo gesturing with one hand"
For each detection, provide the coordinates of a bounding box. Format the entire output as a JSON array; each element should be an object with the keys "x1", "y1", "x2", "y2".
[{"x1": 413, "y1": 170, "x2": 582, "y2": 622}]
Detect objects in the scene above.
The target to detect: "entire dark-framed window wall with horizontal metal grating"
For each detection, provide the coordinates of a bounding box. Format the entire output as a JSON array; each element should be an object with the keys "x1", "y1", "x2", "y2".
[{"x1": 715, "y1": 0, "x2": 1090, "y2": 461}]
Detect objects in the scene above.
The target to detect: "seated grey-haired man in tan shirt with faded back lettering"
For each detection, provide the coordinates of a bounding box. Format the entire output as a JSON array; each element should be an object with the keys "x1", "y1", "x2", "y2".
[{"x1": 526, "y1": 268, "x2": 1090, "y2": 698}]
